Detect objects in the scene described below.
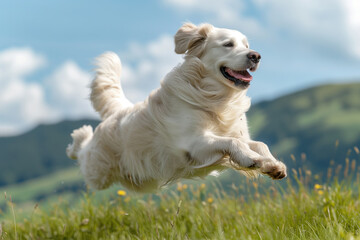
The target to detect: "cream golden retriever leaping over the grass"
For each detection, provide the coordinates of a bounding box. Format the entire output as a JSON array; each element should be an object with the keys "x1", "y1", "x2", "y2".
[{"x1": 67, "y1": 23, "x2": 286, "y2": 192}]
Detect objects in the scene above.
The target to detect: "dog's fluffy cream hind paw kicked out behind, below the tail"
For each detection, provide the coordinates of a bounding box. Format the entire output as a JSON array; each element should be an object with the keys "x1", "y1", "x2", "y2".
[{"x1": 66, "y1": 125, "x2": 93, "y2": 160}]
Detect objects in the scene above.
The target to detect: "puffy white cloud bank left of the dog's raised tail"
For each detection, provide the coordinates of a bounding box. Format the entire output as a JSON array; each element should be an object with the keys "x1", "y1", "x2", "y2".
[{"x1": 0, "y1": 48, "x2": 96, "y2": 136}]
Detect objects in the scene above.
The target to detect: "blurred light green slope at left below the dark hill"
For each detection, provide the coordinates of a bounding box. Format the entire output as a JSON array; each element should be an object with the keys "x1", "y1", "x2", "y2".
[{"x1": 0, "y1": 167, "x2": 123, "y2": 222}]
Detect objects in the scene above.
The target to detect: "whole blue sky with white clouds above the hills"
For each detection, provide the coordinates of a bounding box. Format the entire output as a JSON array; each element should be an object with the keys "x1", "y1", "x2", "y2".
[{"x1": 0, "y1": 0, "x2": 360, "y2": 136}]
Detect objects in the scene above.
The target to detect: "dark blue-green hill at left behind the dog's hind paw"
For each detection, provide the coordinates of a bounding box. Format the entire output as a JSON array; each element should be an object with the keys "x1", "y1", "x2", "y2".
[{"x1": 0, "y1": 120, "x2": 98, "y2": 186}]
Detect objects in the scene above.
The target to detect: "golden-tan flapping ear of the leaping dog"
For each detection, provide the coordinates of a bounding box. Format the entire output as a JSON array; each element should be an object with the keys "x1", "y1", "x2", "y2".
[{"x1": 175, "y1": 23, "x2": 214, "y2": 57}]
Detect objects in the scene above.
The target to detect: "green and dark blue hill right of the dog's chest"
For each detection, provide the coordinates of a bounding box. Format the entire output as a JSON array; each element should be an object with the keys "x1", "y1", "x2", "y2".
[{"x1": 248, "y1": 83, "x2": 360, "y2": 172}]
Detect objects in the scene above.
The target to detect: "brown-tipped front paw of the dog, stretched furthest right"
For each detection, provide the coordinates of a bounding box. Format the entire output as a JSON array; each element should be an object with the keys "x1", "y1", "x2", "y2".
[{"x1": 255, "y1": 160, "x2": 286, "y2": 180}]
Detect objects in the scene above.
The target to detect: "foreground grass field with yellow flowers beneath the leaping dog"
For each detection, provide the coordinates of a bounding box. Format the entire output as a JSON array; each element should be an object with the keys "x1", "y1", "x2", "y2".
[{"x1": 0, "y1": 149, "x2": 360, "y2": 240}]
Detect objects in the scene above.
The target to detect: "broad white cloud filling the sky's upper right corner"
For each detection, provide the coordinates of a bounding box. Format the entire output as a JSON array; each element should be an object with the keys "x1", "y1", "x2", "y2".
[{"x1": 163, "y1": 0, "x2": 360, "y2": 59}]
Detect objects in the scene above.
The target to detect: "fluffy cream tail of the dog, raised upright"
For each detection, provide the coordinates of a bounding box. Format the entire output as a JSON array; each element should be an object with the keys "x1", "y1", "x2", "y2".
[{"x1": 90, "y1": 52, "x2": 132, "y2": 119}]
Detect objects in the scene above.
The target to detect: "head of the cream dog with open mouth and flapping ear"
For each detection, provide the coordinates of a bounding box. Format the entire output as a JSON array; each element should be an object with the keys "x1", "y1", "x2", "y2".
[{"x1": 175, "y1": 23, "x2": 261, "y2": 89}]
